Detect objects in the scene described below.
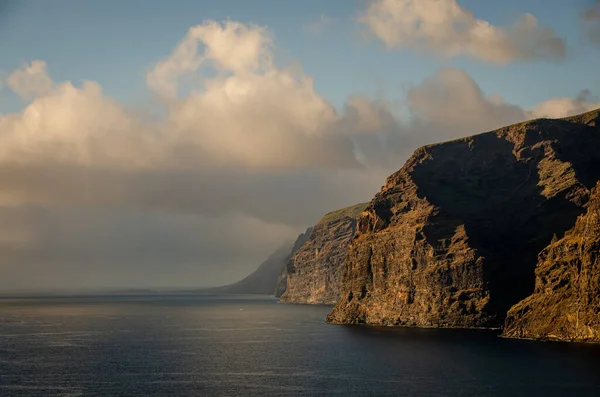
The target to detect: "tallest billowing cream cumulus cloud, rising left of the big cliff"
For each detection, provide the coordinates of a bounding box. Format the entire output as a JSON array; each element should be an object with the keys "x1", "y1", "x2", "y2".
[{"x1": 148, "y1": 21, "x2": 355, "y2": 167}]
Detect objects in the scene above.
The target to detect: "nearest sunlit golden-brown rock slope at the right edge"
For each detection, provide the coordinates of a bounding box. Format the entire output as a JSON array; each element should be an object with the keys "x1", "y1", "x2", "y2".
[{"x1": 504, "y1": 183, "x2": 600, "y2": 342}]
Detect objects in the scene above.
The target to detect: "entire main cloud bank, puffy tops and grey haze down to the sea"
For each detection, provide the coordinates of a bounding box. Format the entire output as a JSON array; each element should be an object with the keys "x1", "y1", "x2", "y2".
[{"x1": 0, "y1": 17, "x2": 594, "y2": 288}]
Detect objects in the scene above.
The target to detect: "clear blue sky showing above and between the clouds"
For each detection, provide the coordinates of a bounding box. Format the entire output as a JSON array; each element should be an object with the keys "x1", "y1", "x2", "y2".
[{"x1": 0, "y1": 0, "x2": 600, "y2": 111}]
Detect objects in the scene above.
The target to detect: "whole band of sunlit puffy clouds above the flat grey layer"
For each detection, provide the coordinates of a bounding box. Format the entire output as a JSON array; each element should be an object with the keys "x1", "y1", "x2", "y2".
[{"x1": 0, "y1": 21, "x2": 580, "y2": 176}]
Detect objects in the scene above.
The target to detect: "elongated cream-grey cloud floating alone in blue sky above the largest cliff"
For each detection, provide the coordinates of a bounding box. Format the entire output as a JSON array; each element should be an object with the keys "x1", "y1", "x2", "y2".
[{"x1": 359, "y1": 0, "x2": 566, "y2": 64}]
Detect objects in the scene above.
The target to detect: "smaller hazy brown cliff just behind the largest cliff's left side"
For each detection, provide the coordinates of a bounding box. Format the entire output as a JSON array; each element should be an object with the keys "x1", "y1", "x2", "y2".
[{"x1": 281, "y1": 203, "x2": 367, "y2": 304}]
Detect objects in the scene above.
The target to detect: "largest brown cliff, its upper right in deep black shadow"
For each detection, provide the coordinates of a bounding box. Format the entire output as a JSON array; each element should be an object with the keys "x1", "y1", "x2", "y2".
[{"x1": 328, "y1": 111, "x2": 600, "y2": 327}]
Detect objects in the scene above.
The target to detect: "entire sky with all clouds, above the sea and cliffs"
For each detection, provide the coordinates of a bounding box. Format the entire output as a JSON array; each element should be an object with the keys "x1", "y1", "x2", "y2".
[{"x1": 0, "y1": 0, "x2": 600, "y2": 292}]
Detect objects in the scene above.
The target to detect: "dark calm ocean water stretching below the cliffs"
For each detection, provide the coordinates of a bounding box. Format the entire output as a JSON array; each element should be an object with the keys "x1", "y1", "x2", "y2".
[{"x1": 0, "y1": 296, "x2": 600, "y2": 397}]
